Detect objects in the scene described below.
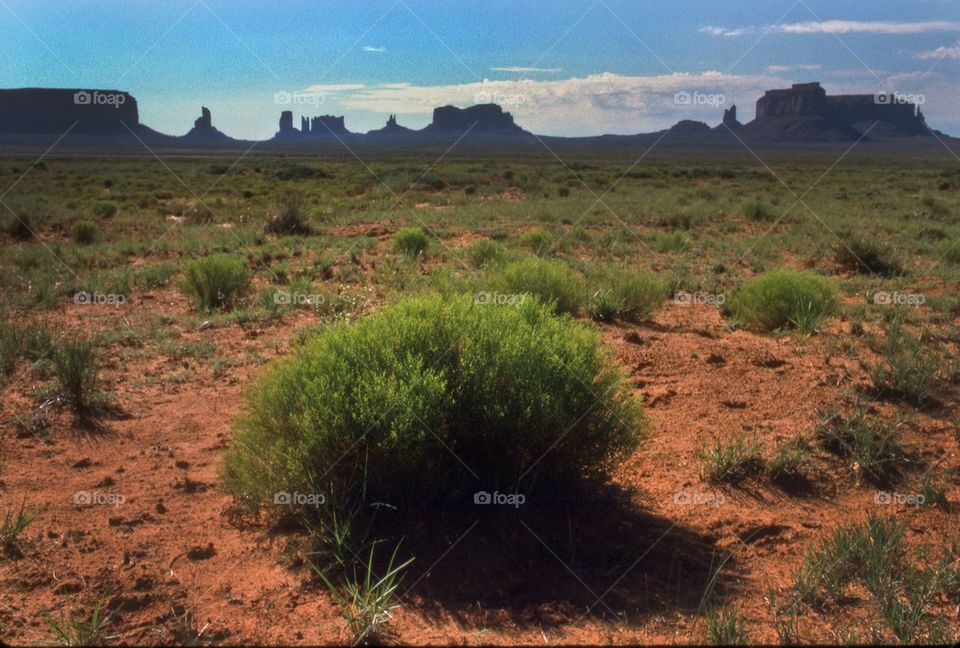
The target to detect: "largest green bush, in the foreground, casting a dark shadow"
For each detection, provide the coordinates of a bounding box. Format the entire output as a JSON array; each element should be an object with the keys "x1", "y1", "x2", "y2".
[{"x1": 223, "y1": 295, "x2": 644, "y2": 510}]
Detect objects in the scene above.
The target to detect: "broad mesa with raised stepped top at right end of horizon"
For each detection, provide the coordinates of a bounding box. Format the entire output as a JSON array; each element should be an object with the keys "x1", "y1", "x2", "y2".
[{"x1": 745, "y1": 83, "x2": 930, "y2": 142}]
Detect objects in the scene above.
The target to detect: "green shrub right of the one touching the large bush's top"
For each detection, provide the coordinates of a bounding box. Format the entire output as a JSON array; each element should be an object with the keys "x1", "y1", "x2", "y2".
[{"x1": 588, "y1": 266, "x2": 667, "y2": 322}]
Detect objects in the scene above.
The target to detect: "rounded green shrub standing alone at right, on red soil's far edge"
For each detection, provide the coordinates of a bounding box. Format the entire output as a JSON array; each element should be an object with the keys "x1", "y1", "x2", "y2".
[{"x1": 729, "y1": 269, "x2": 839, "y2": 331}]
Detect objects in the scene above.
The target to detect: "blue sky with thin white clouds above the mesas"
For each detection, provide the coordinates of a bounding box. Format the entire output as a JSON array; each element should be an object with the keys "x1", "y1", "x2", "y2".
[{"x1": 0, "y1": 0, "x2": 960, "y2": 138}]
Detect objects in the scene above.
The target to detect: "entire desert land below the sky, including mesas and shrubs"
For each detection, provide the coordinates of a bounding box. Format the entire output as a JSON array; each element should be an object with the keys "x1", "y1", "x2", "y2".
[{"x1": 0, "y1": 2, "x2": 960, "y2": 646}]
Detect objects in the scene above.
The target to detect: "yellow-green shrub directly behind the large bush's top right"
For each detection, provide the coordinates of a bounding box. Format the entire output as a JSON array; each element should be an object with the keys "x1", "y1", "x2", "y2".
[{"x1": 494, "y1": 257, "x2": 586, "y2": 314}]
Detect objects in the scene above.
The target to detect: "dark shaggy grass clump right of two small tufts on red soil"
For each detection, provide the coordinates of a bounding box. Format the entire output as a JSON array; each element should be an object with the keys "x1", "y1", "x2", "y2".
[{"x1": 815, "y1": 404, "x2": 903, "y2": 485}]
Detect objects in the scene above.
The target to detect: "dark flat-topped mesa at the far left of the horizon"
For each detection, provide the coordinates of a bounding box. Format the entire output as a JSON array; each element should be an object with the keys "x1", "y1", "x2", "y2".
[{"x1": 0, "y1": 88, "x2": 140, "y2": 135}]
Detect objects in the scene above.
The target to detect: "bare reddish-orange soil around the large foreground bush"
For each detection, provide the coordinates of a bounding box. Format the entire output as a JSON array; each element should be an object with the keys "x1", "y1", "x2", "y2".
[{"x1": 0, "y1": 262, "x2": 960, "y2": 644}]
